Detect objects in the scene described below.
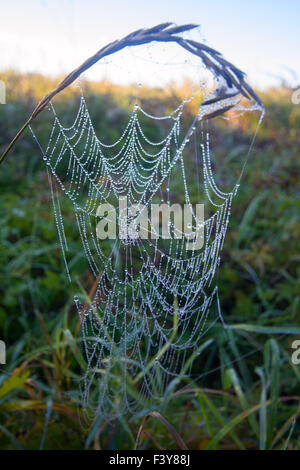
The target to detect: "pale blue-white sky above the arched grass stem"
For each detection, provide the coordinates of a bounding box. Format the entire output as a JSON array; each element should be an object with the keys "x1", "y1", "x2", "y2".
[{"x1": 0, "y1": 0, "x2": 300, "y2": 87}]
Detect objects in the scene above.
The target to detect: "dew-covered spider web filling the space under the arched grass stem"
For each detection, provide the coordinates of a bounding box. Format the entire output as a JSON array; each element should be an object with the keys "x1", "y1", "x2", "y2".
[{"x1": 27, "y1": 27, "x2": 262, "y2": 418}]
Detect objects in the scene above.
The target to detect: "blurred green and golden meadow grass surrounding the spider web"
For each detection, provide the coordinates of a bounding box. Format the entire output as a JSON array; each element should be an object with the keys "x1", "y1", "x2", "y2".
[{"x1": 0, "y1": 71, "x2": 300, "y2": 450}]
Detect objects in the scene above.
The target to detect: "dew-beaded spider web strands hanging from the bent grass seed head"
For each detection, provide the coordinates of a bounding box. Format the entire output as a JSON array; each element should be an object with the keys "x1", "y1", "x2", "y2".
[{"x1": 30, "y1": 34, "x2": 262, "y2": 419}]
